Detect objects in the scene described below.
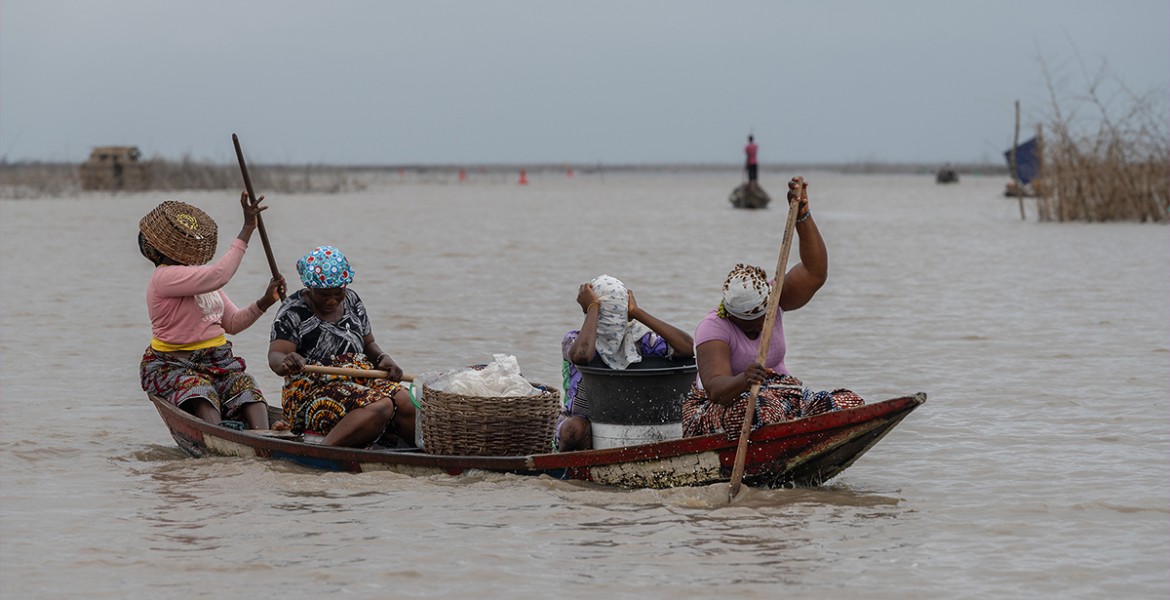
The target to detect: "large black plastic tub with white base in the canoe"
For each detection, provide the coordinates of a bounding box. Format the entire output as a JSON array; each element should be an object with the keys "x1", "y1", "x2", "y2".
[{"x1": 577, "y1": 357, "x2": 698, "y2": 448}]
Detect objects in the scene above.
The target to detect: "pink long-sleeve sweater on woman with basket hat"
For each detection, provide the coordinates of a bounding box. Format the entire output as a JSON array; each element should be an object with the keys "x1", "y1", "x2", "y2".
[{"x1": 146, "y1": 239, "x2": 263, "y2": 350}]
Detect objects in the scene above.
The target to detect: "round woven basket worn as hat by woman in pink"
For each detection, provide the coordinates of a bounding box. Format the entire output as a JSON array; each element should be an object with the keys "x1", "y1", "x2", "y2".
[{"x1": 138, "y1": 200, "x2": 219, "y2": 264}]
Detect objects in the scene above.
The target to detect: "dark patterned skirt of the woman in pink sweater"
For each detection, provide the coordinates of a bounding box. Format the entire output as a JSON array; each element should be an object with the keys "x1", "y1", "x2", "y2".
[{"x1": 138, "y1": 342, "x2": 264, "y2": 421}]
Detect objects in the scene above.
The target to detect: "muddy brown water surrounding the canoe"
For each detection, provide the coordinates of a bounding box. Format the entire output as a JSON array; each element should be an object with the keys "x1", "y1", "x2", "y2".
[{"x1": 0, "y1": 171, "x2": 1170, "y2": 600}]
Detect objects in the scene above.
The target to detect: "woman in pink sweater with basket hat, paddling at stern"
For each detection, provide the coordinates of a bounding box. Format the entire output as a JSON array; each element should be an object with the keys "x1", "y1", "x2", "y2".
[{"x1": 138, "y1": 192, "x2": 284, "y2": 429}]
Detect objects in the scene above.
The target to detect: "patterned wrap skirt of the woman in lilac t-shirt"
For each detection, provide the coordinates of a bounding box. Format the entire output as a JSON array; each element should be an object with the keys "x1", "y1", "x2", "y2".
[{"x1": 682, "y1": 373, "x2": 866, "y2": 437}]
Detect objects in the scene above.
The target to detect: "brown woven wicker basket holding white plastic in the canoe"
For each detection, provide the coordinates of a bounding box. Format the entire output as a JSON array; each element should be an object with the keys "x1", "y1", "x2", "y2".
[{"x1": 420, "y1": 384, "x2": 560, "y2": 456}]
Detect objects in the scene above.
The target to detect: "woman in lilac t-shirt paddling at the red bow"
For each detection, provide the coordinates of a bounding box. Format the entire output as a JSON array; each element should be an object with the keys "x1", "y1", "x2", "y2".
[{"x1": 682, "y1": 179, "x2": 863, "y2": 436}]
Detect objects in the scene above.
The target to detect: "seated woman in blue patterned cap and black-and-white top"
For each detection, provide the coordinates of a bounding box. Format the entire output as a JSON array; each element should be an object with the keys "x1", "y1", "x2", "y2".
[{"x1": 268, "y1": 246, "x2": 414, "y2": 448}]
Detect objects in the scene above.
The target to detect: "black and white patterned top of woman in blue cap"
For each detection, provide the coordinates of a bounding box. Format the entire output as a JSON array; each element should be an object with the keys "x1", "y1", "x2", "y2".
[{"x1": 269, "y1": 288, "x2": 372, "y2": 365}]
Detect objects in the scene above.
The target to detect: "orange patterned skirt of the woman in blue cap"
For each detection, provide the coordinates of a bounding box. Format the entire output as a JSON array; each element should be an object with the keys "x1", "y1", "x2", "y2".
[{"x1": 281, "y1": 353, "x2": 402, "y2": 439}]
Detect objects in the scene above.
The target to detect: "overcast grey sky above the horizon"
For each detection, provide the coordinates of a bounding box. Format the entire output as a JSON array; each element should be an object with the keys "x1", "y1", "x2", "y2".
[{"x1": 0, "y1": 0, "x2": 1170, "y2": 164}]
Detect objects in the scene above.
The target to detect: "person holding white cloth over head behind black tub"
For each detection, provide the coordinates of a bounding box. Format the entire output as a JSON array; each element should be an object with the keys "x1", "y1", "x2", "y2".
[{"x1": 555, "y1": 275, "x2": 695, "y2": 451}]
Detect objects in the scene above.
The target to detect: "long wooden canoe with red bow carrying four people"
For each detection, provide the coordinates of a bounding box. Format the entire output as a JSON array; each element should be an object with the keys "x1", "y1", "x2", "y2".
[{"x1": 150, "y1": 393, "x2": 927, "y2": 488}]
